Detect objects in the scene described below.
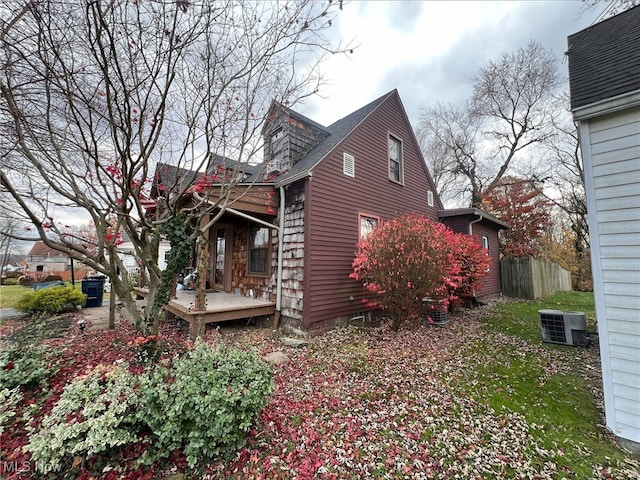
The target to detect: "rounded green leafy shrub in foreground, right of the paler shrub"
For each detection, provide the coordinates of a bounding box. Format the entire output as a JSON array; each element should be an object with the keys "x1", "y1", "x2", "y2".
[{"x1": 138, "y1": 341, "x2": 273, "y2": 468}]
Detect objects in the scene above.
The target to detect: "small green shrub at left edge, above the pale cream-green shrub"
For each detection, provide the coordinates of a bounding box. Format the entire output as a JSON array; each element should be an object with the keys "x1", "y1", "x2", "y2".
[{"x1": 0, "y1": 343, "x2": 55, "y2": 389}]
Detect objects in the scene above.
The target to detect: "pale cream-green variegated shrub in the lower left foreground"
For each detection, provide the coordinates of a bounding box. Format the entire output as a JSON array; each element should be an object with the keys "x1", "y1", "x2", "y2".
[{"x1": 25, "y1": 365, "x2": 138, "y2": 472}]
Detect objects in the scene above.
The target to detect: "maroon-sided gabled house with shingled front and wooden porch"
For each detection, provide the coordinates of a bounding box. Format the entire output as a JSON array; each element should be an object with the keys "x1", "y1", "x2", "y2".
[{"x1": 155, "y1": 90, "x2": 508, "y2": 333}]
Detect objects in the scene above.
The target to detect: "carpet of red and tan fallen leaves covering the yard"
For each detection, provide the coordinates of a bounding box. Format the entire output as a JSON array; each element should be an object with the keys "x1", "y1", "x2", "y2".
[{"x1": 0, "y1": 302, "x2": 640, "y2": 480}]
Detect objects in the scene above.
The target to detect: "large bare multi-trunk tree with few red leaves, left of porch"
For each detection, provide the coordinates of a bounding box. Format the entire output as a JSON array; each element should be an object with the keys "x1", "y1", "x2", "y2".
[{"x1": 0, "y1": 0, "x2": 342, "y2": 331}]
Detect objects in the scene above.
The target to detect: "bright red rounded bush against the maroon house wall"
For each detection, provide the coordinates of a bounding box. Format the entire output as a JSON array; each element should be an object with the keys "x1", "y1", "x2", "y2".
[{"x1": 350, "y1": 213, "x2": 489, "y2": 330}]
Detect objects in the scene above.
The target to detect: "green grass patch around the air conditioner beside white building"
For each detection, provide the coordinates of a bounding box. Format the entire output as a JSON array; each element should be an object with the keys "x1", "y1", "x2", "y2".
[{"x1": 456, "y1": 292, "x2": 625, "y2": 478}]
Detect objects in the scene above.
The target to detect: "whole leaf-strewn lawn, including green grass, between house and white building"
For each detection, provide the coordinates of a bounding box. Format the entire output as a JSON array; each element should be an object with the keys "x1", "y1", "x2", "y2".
[{"x1": 0, "y1": 293, "x2": 640, "y2": 479}]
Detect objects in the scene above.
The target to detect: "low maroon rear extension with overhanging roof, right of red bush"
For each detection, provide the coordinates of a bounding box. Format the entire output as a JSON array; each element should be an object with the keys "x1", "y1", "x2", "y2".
[{"x1": 438, "y1": 208, "x2": 509, "y2": 298}]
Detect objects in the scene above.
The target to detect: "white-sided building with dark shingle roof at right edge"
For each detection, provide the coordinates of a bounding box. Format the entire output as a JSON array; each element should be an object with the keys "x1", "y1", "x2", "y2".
[{"x1": 567, "y1": 6, "x2": 640, "y2": 451}]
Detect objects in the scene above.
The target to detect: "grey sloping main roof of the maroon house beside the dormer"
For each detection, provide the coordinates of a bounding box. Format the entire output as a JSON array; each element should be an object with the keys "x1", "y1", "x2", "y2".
[{"x1": 276, "y1": 89, "x2": 397, "y2": 187}]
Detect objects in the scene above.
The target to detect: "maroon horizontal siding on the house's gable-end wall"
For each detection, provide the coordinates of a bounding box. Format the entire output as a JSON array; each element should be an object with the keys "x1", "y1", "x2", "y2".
[{"x1": 303, "y1": 93, "x2": 441, "y2": 330}]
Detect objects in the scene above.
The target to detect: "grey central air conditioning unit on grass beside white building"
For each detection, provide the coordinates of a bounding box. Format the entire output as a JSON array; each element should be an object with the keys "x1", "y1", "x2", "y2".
[{"x1": 538, "y1": 310, "x2": 589, "y2": 347}]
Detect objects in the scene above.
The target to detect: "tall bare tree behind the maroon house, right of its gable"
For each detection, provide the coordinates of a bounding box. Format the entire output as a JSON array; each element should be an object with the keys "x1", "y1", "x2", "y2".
[{"x1": 419, "y1": 42, "x2": 559, "y2": 205}]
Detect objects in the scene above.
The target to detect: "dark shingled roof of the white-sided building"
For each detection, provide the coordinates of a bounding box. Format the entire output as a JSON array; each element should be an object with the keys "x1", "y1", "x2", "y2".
[{"x1": 566, "y1": 5, "x2": 640, "y2": 110}]
